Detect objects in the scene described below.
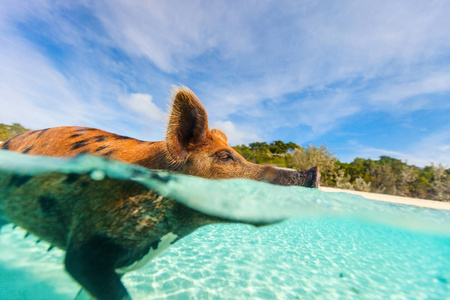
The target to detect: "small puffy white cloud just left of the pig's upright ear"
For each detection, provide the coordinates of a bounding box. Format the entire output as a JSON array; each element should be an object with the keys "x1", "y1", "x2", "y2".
[{"x1": 119, "y1": 94, "x2": 166, "y2": 122}]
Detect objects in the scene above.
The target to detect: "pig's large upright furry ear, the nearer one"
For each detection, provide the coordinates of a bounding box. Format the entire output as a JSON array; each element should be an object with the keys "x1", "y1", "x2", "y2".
[{"x1": 166, "y1": 87, "x2": 209, "y2": 162}]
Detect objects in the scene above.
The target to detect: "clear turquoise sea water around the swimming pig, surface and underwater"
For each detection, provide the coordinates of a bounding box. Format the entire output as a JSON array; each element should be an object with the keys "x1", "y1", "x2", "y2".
[{"x1": 0, "y1": 151, "x2": 450, "y2": 299}]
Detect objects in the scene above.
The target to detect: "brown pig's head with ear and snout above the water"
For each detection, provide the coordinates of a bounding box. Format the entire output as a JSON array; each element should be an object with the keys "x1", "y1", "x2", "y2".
[{"x1": 166, "y1": 87, "x2": 320, "y2": 188}]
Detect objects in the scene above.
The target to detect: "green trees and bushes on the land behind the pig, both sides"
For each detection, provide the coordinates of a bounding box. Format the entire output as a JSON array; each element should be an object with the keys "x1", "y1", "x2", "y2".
[{"x1": 0, "y1": 123, "x2": 450, "y2": 201}]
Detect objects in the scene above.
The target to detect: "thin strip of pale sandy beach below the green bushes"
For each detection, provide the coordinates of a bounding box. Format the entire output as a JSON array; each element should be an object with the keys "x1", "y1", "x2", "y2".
[{"x1": 319, "y1": 187, "x2": 450, "y2": 210}]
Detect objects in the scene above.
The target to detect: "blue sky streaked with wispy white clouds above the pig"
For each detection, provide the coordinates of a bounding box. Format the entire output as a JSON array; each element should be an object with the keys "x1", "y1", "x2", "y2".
[{"x1": 0, "y1": 0, "x2": 450, "y2": 167}]
